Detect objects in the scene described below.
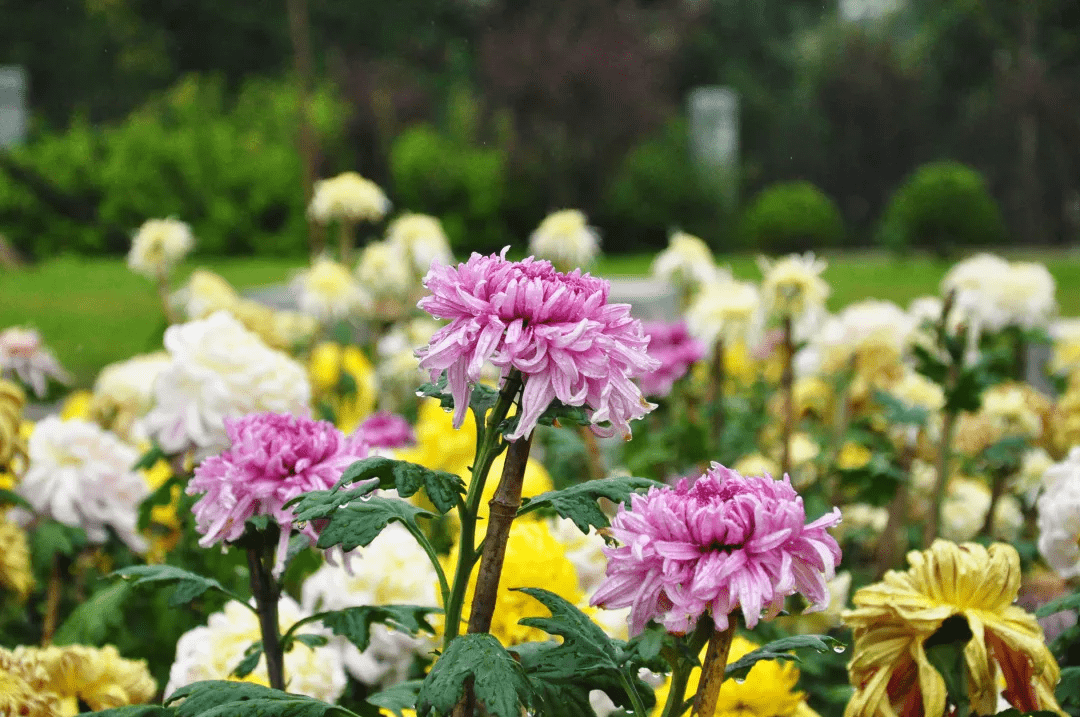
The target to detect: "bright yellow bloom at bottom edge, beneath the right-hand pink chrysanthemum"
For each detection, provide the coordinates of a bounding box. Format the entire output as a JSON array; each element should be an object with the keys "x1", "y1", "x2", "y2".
[{"x1": 652, "y1": 635, "x2": 818, "y2": 717}]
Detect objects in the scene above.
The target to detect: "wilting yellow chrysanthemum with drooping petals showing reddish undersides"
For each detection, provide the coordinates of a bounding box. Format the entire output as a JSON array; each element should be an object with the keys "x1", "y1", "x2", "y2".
[{"x1": 843, "y1": 540, "x2": 1065, "y2": 717}]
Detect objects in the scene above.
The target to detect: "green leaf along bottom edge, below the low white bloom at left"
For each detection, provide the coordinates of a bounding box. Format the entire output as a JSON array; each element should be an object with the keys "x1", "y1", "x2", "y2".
[{"x1": 165, "y1": 680, "x2": 353, "y2": 717}]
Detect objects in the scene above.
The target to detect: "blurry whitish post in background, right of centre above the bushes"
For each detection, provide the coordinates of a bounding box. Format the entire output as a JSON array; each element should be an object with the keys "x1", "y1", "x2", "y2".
[{"x1": 689, "y1": 86, "x2": 739, "y2": 207}]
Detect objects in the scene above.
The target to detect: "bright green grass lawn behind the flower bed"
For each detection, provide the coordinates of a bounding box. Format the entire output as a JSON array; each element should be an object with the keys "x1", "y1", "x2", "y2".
[{"x1": 0, "y1": 252, "x2": 1080, "y2": 387}]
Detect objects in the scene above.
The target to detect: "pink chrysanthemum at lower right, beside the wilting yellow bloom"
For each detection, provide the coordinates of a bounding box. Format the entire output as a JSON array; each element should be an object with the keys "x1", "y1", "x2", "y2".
[{"x1": 592, "y1": 463, "x2": 840, "y2": 635}]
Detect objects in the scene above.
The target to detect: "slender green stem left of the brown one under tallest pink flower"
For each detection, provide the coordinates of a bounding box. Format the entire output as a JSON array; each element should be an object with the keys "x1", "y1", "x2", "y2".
[{"x1": 443, "y1": 370, "x2": 522, "y2": 649}]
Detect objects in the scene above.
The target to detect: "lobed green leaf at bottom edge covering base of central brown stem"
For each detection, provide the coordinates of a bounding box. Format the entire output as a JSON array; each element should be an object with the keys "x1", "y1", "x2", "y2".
[{"x1": 417, "y1": 633, "x2": 534, "y2": 717}]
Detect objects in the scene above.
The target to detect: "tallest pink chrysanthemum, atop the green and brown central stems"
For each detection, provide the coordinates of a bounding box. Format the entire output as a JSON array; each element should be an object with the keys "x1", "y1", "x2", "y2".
[{"x1": 417, "y1": 247, "x2": 660, "y2": 439}]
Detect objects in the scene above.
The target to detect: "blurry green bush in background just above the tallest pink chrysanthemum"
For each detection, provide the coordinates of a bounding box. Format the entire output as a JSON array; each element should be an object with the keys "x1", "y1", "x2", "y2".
[{"x1": 390, "y1": 124, "x2": 510, "y2": 255}]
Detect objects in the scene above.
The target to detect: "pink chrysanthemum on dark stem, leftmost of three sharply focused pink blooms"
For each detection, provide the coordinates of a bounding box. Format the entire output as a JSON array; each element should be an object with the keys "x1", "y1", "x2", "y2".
[{"x1": 187, "y1": 414, "x2": 367, "y2": 573}]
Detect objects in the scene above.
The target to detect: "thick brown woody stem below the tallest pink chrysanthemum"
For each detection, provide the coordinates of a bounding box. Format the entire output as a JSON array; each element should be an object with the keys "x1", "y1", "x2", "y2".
[{"x1": 469, "y1": 433, "x2": 532, "y2": 633}]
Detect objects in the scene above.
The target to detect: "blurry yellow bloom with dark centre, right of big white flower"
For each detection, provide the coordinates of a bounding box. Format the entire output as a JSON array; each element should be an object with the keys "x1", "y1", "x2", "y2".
[{"x1": 308, "y1": 341, "x2": 379, "y2": 433}]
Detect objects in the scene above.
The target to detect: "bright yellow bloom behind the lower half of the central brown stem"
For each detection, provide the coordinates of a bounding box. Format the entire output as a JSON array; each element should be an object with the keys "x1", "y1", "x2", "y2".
[{"x1": 448, "y1": 518, "x2": 584, "y2": 647}]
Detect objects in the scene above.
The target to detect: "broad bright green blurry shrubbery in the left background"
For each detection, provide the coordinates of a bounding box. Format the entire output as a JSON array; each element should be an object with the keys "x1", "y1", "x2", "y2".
[{"x1": 0, "y1": 76, "x2": 343, "y2": 258}]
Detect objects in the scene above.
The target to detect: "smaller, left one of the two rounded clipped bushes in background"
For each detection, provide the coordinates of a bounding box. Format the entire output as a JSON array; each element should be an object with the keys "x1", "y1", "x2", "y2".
[{"x1": 739, "y1": 181, "x2": 845, "y2": 254}]
